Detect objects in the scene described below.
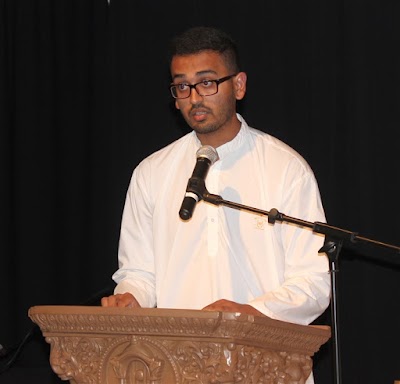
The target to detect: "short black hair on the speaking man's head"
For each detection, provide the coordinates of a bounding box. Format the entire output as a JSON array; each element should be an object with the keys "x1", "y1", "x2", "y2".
[{"x1": 169, "y1": 26, "x2": 240, "y2": 73}]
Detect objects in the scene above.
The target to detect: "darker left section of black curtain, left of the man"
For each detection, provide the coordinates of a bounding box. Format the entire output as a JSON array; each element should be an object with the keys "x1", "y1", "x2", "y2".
[{"x1": 0, "y1": 0, "x2": 117, "y2": 383}]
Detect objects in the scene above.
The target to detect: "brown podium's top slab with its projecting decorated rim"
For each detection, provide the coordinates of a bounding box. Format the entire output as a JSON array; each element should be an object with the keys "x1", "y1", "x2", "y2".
[{"x1": 28, "y1": 305, "x2": 331, "y2": 355}]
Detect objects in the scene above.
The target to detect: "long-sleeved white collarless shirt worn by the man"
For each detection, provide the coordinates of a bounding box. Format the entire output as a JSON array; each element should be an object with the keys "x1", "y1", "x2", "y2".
[{"x1": 113, "y1": 115, "x2": 330, "y2": 324}]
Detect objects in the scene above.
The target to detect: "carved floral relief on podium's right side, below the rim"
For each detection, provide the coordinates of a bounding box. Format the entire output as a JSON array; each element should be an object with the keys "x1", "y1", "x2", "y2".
[{"x1": 164, "y1": 341, "x2": 312, "y2": 384}]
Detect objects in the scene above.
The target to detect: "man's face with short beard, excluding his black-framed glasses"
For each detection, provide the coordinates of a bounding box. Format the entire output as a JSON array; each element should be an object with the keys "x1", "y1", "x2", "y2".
[{"x1": 171, "y1": 51, "x2": 244, "y2": 138}]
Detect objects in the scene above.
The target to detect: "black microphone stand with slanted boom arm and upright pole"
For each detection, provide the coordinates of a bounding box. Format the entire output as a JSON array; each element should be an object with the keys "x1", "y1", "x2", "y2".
[{"x1": 202, "y1": 191, "x2": 400, "y2": 384}]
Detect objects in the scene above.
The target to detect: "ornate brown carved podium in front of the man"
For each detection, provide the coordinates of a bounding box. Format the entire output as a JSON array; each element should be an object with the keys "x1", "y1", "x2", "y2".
[{"x1": 28, "y1": 306, "x2": 331, "y2": 384}]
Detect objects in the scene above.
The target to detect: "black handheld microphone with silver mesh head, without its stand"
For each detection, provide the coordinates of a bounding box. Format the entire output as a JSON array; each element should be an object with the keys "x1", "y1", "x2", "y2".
[{"x1": 179, "y1": 145, "x2": 219, "y2": 220}]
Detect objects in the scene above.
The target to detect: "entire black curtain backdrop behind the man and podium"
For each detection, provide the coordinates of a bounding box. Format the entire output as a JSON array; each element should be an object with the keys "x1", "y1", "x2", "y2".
[{"x1": 0, "y1": 0, "x2": 400, "y2": 384}]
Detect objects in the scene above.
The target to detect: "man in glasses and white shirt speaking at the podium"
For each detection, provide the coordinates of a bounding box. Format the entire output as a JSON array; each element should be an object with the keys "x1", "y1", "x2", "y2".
[{"x1": 102, "y1": 27, "x2": 330, "y2": 383}]
